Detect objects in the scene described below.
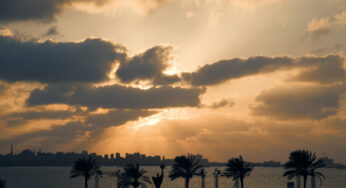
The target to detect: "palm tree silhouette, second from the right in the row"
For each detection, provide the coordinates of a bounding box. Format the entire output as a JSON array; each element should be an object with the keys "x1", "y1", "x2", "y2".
[{"x1": 226, "y1": 155, "x2": 253, "y2": 188}]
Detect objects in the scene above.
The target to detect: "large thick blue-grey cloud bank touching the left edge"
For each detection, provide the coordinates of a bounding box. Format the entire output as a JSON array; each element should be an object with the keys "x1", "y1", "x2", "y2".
[{"x1": 0, "y1": 36, "x2": 126, "y2": 83}]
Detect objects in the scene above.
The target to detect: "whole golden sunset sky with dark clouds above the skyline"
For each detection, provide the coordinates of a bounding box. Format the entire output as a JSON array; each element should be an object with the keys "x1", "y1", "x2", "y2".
[{"x1": 0, "y1": 0, "x2": 346, "y2": 164}]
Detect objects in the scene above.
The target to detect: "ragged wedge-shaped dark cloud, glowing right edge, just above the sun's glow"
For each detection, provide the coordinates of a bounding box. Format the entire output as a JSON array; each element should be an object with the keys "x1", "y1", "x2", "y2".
[{"x1": 116, "y1": 46, "x2": 180, "y2": 85}]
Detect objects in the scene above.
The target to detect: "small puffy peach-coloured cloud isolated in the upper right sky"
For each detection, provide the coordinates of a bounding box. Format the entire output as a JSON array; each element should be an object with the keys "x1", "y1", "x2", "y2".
[{"x1": 306, "y1": 17, "x2": 330, "y2": 39}]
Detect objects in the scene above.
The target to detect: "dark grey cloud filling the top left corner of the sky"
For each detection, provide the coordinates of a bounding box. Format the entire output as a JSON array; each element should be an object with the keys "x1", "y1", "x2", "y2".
[{"x1": 0, "y1": 0, "x2": 107, "y2": 22}]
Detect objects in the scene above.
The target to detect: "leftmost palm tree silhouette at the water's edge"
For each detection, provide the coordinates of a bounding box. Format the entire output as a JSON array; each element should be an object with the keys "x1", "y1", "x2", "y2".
[{"x1": 70, "y1": 157, "x2": 102, "y2": 188}]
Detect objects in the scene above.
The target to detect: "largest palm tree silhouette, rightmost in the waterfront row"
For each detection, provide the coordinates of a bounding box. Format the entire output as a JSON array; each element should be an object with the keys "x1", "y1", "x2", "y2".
[{"x1": 283, "y1": 150, "x2": 325, "y2": 188}]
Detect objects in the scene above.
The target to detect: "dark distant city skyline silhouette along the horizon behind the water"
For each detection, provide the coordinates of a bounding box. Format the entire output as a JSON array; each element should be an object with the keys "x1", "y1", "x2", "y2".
[{"x1": 0, "y1": 149, "x2": 346, "y2": 168}]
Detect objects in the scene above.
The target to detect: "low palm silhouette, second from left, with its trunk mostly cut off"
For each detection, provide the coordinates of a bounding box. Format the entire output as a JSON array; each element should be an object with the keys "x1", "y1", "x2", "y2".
[{"x1": 118, "y1": 164, "x2": 151, "y2": 188}]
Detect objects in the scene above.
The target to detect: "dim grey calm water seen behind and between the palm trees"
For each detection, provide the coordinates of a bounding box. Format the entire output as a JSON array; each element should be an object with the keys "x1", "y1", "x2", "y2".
[{"x1": 0, "y1": 167, "x2": 346, "y2": 188}]
